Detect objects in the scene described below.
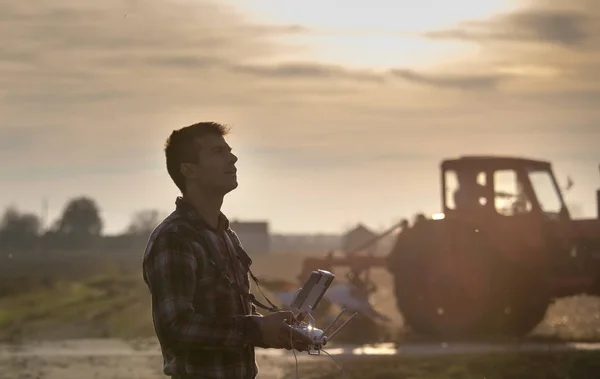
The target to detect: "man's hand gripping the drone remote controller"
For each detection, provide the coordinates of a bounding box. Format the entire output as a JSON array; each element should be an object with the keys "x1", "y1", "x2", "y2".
[{"x1": 261, "y1": 311, "x2": 311, "y2": 351}]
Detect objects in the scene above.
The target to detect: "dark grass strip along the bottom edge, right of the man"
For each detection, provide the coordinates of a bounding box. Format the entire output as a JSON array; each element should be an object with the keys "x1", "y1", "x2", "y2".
[{"x1": 300, "y1": 352, "x2": 600, "y2": 379}]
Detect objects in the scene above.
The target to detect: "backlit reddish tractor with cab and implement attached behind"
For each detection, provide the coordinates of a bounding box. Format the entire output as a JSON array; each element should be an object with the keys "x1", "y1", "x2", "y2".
[{"x1": 300, "y1": 156, "x2": 600, "y2": 338}]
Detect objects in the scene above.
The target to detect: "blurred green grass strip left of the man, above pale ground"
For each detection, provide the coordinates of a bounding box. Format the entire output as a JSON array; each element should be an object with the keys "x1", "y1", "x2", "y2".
[{"x1": 0, "y1": 274, "x2": 153, "y2": 340}]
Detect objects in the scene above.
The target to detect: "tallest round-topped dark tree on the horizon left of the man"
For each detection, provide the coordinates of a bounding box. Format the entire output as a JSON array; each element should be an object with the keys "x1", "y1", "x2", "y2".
[{"x1": 56, "y1": 196, "x2": 103, "y2": 242}]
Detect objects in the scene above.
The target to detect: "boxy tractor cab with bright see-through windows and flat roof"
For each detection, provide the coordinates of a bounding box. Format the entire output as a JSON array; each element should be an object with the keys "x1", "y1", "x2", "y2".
[{"x1": 441, "y1": 156, "x2": 570, "y2": 221}]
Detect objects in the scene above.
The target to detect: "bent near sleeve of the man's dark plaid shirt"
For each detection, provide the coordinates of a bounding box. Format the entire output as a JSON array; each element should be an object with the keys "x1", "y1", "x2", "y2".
[{"x1": 144, "y1": 233, "x2": 260, "y2": 349}]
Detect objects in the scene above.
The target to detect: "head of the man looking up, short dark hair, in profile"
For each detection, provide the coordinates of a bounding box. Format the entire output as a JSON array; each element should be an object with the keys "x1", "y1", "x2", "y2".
[{"x1": 165, "y1": 122, "x2": 238, "y2": 195}]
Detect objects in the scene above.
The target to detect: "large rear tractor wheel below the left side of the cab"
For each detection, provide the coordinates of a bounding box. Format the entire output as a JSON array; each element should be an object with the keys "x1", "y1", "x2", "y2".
[{"x1": 391, "y1": 219, "x2": 497, "y2": 338}]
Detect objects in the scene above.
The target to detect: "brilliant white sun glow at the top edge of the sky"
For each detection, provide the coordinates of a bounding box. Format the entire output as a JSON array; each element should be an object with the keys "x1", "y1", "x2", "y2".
[{"x1": 226, "y1": 0, "x2": 514, "y2": 68}]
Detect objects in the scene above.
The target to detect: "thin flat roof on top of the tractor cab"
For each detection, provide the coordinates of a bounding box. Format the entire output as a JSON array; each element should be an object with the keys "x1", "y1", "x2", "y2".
[{"x1": 442, "y1": 155, "x2": 551, "y2": 170}]
